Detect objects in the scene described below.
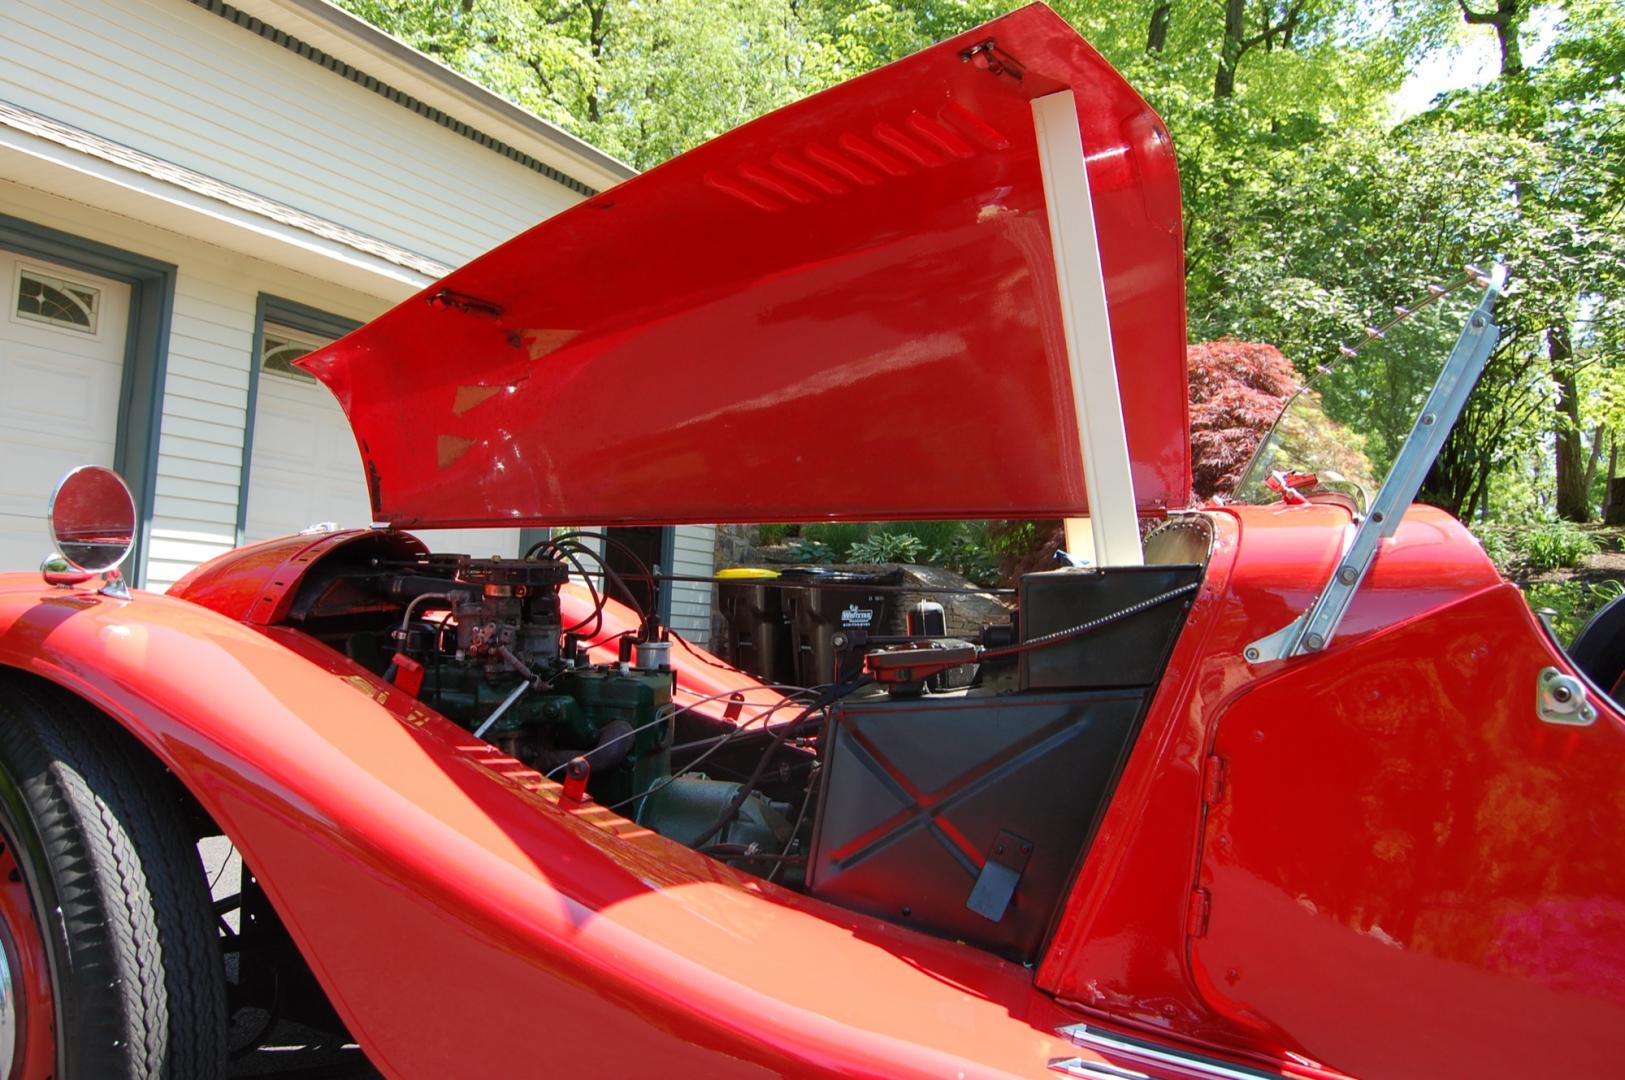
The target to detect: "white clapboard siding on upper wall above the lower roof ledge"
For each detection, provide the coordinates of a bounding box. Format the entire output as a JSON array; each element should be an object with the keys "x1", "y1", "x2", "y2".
[{"x1": 0, "y1": 0, "x2": 579, "y2": 267}]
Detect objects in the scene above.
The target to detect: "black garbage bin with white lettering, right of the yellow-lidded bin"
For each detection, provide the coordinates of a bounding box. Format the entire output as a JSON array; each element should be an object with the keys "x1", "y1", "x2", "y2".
[{"x1": 778, "y1": 567, "x2": 902, "y2": 687}]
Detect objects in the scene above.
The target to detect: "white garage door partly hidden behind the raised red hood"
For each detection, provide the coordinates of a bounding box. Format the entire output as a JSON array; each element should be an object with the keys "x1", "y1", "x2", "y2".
[{"x1": 245, "y1": 323, "x2": 518, "y2": 557}]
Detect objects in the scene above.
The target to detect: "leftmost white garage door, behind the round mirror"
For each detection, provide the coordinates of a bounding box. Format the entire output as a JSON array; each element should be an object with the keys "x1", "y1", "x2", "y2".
[{"x1": 0, "y1": 250, "x2": 130, "y2": 570}]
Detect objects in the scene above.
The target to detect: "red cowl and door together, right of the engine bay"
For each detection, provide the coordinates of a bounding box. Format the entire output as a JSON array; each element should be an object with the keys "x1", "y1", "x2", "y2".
[{"x1": 1038, "y1": 505, "x2": 1625, "y2": 1077}]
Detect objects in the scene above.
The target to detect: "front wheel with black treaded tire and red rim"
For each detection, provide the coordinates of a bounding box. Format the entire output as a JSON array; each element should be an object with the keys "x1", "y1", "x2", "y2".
[{"x1": 0, "y1": 677, "x2": 226, "y2": 1080}]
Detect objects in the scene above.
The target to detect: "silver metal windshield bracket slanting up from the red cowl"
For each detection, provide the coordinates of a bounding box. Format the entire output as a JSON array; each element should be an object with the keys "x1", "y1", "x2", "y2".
[{"x1": 1243, "y1": 265, "x2": 1506, "y2": 664}]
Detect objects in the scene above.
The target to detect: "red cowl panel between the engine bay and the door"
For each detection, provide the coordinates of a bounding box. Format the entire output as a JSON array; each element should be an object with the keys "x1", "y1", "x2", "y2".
[{"x1": 1038, "y1": 505, "x2": 1532, "y2": 1069}]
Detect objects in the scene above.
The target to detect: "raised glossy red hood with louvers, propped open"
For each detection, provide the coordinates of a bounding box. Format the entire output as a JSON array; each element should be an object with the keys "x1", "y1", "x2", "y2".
[{"x1": 301, "y1": 5, "x2": 1190, "y2": 528}]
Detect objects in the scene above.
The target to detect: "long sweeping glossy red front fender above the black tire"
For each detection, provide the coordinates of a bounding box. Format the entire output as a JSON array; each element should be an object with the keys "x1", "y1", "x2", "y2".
[{"x1": 0, "y1": 575, "x2": 1077, "y2": 1077}]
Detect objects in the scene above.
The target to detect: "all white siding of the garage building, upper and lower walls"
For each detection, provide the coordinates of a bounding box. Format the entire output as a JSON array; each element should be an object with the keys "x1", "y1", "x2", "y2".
[{"x1": 0, "y1": 0, "x2": 712, "y2": 623}]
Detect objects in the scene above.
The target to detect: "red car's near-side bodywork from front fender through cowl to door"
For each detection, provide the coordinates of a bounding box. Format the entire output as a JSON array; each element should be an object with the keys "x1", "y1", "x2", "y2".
[{"x1": 0, "y1": 505, "x2": 1625, "y2": 1077}]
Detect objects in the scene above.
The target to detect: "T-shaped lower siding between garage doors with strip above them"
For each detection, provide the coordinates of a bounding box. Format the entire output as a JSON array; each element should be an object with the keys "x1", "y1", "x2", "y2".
[{"x1": 0, "y1": 182, "x2": 390, "y2": 590}]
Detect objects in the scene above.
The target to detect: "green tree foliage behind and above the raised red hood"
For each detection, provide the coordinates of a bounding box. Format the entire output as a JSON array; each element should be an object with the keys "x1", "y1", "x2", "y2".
[{"x1": 340, "y1": 0, "x2": 1625, "y2": 518}]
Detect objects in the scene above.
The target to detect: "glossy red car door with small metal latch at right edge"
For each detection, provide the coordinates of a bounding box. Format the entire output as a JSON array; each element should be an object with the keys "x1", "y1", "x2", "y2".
[{"x1": 1191, "y1": 585, "x2": 1625, "y2": 1080}]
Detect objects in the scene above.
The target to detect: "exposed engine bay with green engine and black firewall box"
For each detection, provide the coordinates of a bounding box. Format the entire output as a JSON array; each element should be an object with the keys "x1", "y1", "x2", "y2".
[{"x1": 269, "y1": 518, "x2": 1209, "y2": 961}]
